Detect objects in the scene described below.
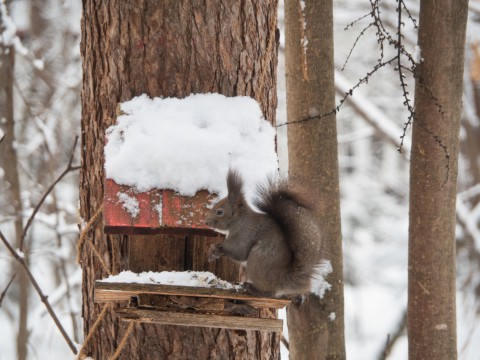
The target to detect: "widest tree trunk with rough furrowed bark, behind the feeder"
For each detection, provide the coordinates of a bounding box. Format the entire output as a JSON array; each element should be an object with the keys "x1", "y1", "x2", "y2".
[{"x1": 80, "y1": 0, "x2": 280, "y2": 360}]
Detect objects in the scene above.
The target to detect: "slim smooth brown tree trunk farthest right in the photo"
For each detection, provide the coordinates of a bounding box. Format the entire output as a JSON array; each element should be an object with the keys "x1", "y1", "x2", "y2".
[{"x1": 408, "y1": 0, "x2": 468, "y2": 360}]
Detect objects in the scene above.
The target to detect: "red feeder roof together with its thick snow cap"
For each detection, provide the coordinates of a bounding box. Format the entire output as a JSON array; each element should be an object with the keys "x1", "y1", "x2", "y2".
[{"x1": 104, "y1": 94, "x2": 278, "y2": 234}]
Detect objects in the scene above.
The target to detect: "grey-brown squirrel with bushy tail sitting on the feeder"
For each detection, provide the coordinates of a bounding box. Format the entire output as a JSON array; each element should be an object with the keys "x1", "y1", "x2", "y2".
[{"x1": 205, "y1": 170, "x2": 331, "y2": 297}]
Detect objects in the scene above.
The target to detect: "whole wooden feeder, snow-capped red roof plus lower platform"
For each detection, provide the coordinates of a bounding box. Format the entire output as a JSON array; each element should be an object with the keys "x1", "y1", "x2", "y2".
[{"x1": 99, "y1": 94, "x2": 289, "y2": 332}]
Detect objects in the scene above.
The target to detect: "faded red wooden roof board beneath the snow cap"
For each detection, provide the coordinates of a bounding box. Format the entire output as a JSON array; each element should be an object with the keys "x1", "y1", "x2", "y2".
[{"x1": 103, "y1": 179, "x2": 216, "y2": 236}]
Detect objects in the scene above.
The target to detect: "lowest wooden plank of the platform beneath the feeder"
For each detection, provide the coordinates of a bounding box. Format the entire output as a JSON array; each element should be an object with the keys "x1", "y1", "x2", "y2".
[{"x1": 116, "y1": 309, "x2": 283, "y2": 332}]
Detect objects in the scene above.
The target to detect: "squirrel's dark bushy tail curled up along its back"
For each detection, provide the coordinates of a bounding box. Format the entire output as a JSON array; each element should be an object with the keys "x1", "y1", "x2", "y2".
[{"x1": 254, "y1": 180, "x2": 323, "y2": 290}]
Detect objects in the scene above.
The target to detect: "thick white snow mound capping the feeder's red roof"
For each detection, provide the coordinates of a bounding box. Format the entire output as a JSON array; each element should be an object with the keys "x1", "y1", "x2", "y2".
[{"x1": 105, "y1": 94, "x2": 278, "y2": 197}]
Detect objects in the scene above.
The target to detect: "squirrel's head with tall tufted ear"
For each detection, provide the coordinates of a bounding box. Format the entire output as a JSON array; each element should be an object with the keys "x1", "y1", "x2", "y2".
[{"x1": 205, "y1": 170, "x2": 247, "y2": 232}]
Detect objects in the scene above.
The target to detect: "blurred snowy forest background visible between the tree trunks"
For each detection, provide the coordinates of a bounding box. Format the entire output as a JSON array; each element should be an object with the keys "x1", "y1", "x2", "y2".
[{"x1": 0, "y1": 0, "x2": 480, "y2": 360}]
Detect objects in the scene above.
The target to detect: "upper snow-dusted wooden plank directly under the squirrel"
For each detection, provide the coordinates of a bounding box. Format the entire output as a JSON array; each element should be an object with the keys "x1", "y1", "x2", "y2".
[{"x1": 94, "y1": 281, "x2": 290, "y2": 309}]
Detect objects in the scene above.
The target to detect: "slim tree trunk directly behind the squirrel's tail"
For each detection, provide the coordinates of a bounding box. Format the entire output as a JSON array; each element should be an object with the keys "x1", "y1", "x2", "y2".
[{"x1": 285, "y1": 0, "x2": 345, "y2": 360}]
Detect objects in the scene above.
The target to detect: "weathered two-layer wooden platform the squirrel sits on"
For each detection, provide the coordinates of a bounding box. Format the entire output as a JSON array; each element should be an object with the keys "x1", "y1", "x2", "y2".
[{"x1": 94, "y1": 281, "x2": 290, "y2": 332}]
